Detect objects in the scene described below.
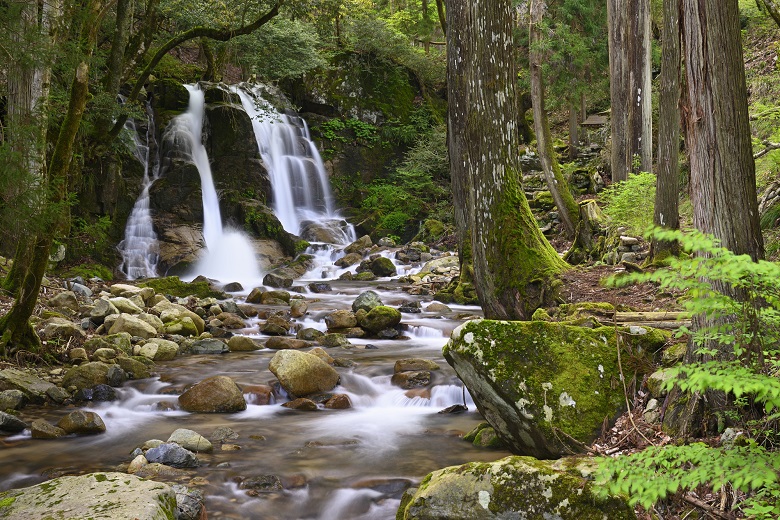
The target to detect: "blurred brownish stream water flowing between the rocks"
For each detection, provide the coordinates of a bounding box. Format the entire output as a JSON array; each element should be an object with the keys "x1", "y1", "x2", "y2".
[{"x1": 0, "y1": 281, "x2": 508, "y2": 520}]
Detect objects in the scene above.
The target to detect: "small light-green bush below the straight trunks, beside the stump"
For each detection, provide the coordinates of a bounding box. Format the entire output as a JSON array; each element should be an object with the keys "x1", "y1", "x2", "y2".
[{"x1": 599, "y1": 172, "x2": 655, "y2": 234}]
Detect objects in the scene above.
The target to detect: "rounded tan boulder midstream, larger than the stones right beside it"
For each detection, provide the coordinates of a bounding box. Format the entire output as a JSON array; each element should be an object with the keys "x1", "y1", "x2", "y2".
[{"x1": 268, "y1": 350, "x2": 339, "y2": 397}]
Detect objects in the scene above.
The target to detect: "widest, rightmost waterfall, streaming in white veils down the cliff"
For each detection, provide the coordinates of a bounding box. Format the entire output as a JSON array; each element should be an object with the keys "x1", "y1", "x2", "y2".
[{"x1": 232, "y1": 87, "x2": 355, "y2": 244}]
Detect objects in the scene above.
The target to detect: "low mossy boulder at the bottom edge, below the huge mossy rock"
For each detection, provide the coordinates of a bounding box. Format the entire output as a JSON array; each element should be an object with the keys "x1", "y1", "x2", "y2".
[{"x1": 396, "y1": 457, "x2": 636, "y2": 520}]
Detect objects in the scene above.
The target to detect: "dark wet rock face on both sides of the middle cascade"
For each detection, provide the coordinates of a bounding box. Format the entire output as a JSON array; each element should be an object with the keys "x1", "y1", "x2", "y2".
[{"x1": 141, "y1": 83, "x2": 295, "y2": 275}]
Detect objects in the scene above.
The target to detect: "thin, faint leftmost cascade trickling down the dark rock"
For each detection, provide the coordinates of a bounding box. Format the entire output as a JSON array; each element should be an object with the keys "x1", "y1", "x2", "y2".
[{"x1": 117, "y1": 103, "x2": 160, "y2": 280}]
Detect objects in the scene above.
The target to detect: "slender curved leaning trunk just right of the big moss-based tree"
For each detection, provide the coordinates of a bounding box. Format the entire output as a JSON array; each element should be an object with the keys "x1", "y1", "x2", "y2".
[{"x1": 529, "y1": 0, "x2": 580, "y2": 240}]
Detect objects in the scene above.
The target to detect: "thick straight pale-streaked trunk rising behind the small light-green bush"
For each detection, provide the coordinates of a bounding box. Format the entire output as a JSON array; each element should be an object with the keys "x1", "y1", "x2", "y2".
[{"x1": 607, "y1": 0, "x2": 653, "y2": 182}]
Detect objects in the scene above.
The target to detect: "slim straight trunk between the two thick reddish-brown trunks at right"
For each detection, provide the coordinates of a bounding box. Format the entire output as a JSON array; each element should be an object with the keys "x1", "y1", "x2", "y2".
[{"x1": 650, "y1": 0, "x2": 681, "y2": 260}]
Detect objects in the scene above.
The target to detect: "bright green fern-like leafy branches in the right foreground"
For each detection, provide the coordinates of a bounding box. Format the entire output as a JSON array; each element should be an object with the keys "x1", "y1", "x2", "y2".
[{"x1": 600, "y1": 229, "x2": 780, "y2": 519}]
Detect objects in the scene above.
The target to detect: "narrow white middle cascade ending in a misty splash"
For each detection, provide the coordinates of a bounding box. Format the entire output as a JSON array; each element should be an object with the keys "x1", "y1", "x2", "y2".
[{"x1": 176, "y1": 85, "x2": 262, "y2": 286}]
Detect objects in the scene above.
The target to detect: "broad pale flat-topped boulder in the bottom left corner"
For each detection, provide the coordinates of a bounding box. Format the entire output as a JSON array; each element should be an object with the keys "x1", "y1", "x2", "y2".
[{"x1": 0, "y1": 472, "x2": 176, "y2": 520}]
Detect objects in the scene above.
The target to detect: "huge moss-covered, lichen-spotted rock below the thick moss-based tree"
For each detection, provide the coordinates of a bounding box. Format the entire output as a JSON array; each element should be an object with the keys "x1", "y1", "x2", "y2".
[{"x1": 444, "y1": 320, "x2": 666, "y2": 459}]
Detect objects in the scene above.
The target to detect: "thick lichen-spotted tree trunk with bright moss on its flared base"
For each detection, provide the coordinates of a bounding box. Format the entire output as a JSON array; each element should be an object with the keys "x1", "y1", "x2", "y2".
[{"x1": 447, "y1": 0, "x2": 566, "y2": 319}]
